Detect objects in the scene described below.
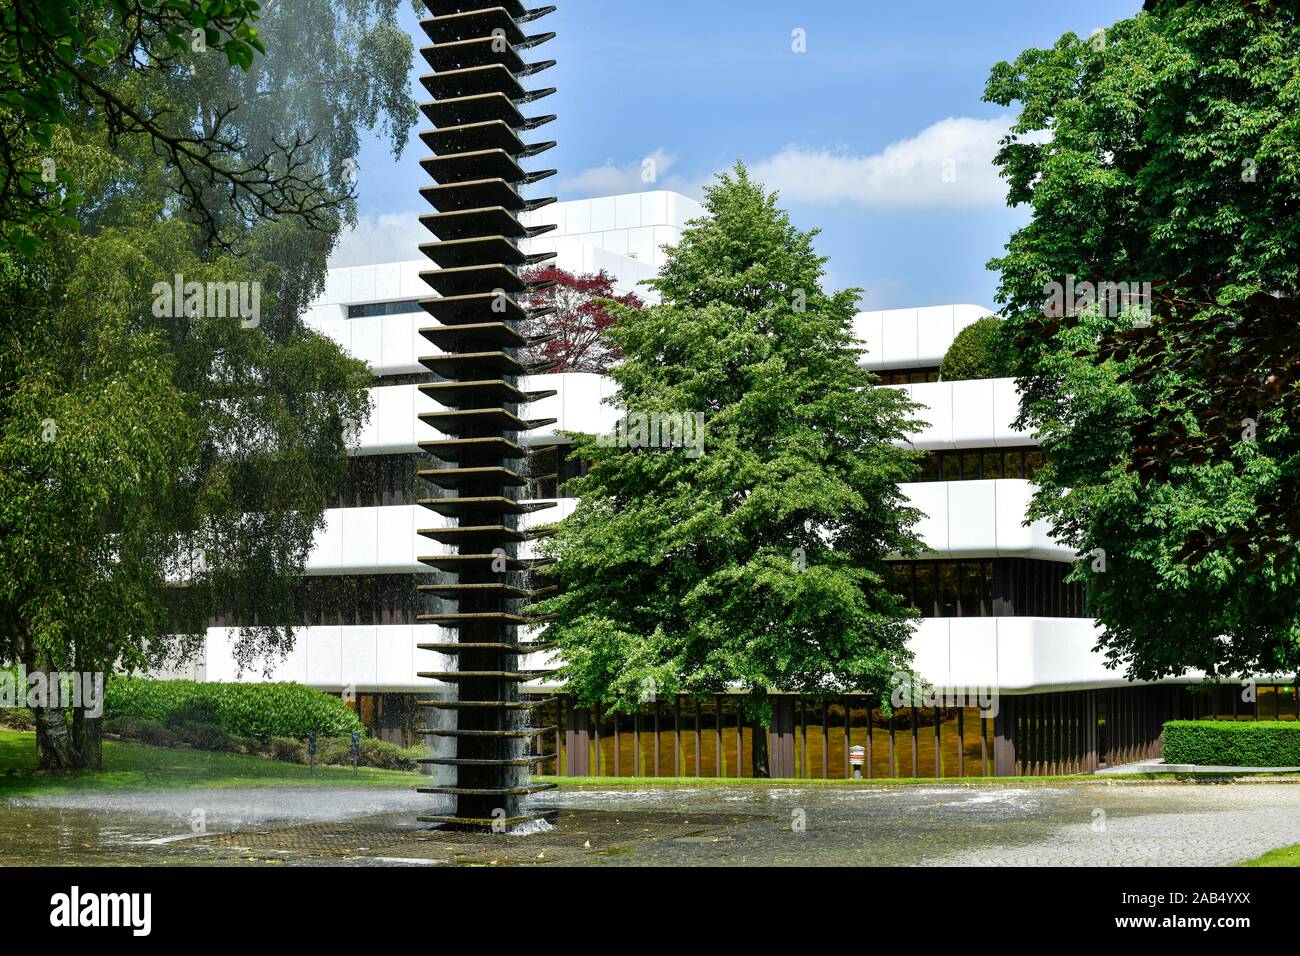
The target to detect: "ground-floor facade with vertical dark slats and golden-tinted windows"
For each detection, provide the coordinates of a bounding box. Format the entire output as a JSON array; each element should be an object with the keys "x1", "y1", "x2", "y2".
[{"x1": 533, "y1": 684, "x2": 1300, "y2": 779}]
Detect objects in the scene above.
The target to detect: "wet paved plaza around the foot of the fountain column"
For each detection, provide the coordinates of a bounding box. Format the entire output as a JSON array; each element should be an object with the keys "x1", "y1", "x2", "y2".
[{"x1": 0, "y1": 782, "x2": 1300, "y2": 866}]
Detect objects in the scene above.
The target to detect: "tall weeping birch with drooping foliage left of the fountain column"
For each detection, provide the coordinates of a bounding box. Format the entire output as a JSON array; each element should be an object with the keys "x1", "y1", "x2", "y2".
[{"x1": 0, "y1": 0, "x2": 415, "y2": 767}]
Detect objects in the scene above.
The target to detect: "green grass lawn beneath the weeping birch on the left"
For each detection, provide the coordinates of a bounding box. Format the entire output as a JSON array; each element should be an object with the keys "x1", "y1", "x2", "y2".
[{"x1": 0, "y1": 730, "x2": 423, "y2": 799}]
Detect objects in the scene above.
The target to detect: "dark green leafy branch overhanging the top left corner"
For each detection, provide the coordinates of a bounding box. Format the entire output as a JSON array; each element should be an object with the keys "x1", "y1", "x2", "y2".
[{"x1": 0, "y1": 0, "x2": 312, "y2": 256}]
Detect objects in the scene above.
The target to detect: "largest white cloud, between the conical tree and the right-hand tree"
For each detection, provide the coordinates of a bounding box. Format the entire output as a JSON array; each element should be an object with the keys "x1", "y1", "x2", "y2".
[{"x1": 750, "y1": 116, "x2": 1029, "y2": 207}]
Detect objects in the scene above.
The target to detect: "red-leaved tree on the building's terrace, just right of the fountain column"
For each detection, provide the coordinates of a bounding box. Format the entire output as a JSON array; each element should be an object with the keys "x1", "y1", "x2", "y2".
[{"x1": 524, "y1": 265, "x2": 645, "y2": 375}]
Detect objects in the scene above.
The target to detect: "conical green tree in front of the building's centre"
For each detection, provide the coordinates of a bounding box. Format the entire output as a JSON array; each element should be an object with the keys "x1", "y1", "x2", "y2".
[{"x1": 540, "y1": 165, "x2": 918, "y2": 775}]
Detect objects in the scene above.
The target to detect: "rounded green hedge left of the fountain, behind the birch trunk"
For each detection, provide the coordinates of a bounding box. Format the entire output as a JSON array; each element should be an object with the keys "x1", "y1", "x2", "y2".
[{"x1": 104, "y1": 676, "x2": 365, "y2": 740}]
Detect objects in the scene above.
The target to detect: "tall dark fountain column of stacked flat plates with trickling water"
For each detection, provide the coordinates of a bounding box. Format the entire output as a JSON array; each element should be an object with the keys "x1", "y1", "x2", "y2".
[{"x1": 417, "y1": 0, "x2": 555, "y2": 831}]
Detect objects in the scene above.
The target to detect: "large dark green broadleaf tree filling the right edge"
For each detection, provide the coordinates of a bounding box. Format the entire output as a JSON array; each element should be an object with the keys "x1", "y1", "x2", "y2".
[{"x1": 985, "y1": 0, "x2": 1300, "y2": 679}]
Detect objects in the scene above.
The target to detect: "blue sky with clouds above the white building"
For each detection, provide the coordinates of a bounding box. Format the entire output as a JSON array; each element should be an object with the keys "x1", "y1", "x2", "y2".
[{"x1": 334, "y1": 0, "x2": 1140, "y2": 308}]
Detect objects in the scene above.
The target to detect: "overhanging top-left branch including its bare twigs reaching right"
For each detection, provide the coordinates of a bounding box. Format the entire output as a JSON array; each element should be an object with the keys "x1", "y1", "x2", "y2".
[{"x1": 0, "y1": 0, "x2": 352, "y2": 255}]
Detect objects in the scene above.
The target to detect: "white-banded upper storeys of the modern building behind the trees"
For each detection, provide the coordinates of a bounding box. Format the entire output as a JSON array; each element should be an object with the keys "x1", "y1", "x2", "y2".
[{"x1": 178, "y1": 191, "x2": 1211, "y2": 775}]
